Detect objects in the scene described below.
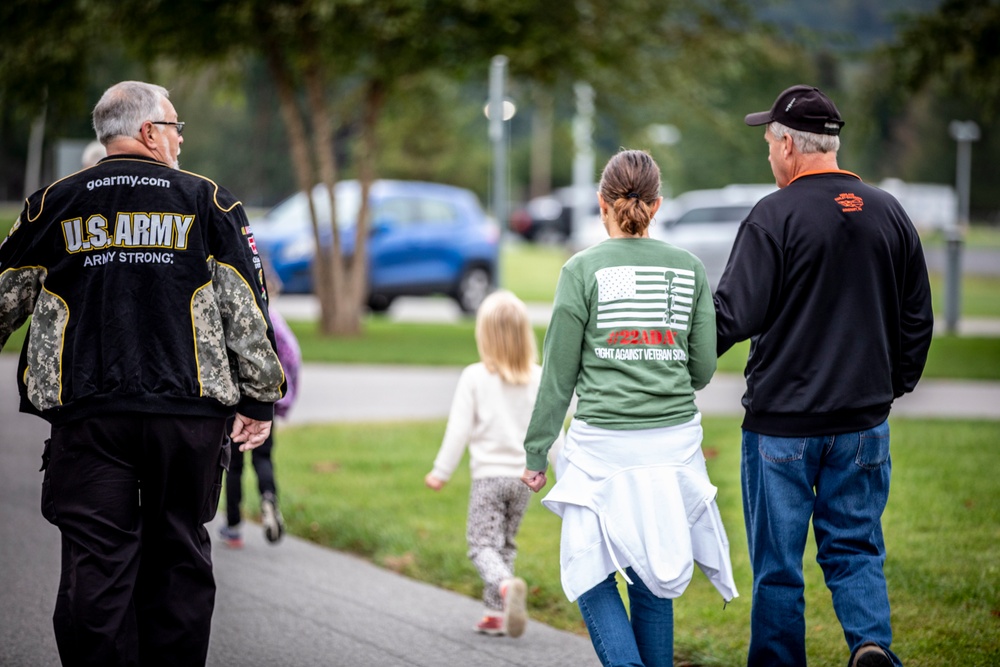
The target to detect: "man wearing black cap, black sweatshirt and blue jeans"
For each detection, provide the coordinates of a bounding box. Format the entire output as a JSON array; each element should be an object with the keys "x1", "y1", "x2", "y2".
[{"x1": 715, "y1": 86, "x2": 933, "y2": 667}]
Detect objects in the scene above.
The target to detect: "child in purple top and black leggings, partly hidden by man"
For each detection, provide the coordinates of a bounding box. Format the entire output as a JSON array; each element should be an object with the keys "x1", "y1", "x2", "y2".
[{"x1": 219, "y1": 261, "x2": 302, "y2": 549}]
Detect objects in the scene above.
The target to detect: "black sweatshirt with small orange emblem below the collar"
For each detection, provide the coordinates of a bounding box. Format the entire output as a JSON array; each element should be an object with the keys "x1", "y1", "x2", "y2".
[{"x1": 715, "y1": 171, "x2": 934, "y2": 437}]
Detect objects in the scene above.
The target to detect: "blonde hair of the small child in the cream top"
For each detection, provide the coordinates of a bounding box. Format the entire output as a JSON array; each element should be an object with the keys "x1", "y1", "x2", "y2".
[{"x1": 476, "y1": 290, "x2": 538, "y2": 384}]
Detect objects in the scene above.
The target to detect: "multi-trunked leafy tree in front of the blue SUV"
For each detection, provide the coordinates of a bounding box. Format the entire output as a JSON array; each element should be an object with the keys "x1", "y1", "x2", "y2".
[{"x1": 0, "y1": 0, "x2": 796, "y2": 334}]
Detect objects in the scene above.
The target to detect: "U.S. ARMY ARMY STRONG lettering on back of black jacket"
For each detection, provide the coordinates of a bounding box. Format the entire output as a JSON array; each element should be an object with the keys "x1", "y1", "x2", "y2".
[{"x1": 62, "y1": 212, "x2": 194, "y2": 266}]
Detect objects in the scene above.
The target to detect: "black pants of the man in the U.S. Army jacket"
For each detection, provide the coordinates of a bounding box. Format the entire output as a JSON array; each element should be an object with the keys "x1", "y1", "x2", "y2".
[{"x1": 42, "y1": 414, "x2": 229, "y2": 667}]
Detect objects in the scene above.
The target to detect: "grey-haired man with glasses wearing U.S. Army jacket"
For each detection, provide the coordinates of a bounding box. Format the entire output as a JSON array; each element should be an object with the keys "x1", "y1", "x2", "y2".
[{"x1": 0, "y1": 81, "x2": 285, "y2": 666}]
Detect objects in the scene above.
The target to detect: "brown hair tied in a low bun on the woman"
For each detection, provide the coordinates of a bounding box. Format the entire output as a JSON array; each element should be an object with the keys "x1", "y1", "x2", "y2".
[{"x1": 599, "y1": 150, "x2": 660, "y2": 236}]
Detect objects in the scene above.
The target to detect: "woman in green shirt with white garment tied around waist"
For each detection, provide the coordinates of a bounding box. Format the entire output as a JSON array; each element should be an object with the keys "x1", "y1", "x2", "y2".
[{"x1": 522, "y1": 150, "x2": 737, "y2": 667}]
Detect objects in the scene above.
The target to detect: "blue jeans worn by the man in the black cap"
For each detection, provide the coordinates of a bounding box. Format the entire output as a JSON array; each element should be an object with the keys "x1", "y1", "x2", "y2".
[{"x1": 742, "y1": 422, "x2": 902, "y2": 667}]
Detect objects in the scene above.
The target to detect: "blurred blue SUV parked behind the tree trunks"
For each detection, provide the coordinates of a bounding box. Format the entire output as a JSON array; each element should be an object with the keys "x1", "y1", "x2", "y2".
[{"x1": 251, "y1": 180, "x2": 500, "y2": 313}]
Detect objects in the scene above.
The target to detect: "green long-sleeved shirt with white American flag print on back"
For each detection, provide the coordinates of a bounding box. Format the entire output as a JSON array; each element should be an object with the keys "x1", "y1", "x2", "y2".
[{"x1": 524, "y1": 238, "x2": 716, "y2": 470}]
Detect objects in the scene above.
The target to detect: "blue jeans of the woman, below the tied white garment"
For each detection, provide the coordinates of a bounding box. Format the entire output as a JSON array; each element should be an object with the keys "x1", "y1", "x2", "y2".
[{"x1": 577, "y1": 567, "x2": 674, "y2": 667}]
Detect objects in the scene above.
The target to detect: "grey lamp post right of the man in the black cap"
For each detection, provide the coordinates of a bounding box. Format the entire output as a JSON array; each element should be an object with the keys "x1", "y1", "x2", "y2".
[{"x1": 944, "y1": 120, "x2": 979, "y2": 334}]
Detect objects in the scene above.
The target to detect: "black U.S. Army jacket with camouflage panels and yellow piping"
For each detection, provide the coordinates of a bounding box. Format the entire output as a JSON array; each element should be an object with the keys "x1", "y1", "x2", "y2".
[{"x1": 0, "y1": 155, "x2": 284, "y2": 423}]
